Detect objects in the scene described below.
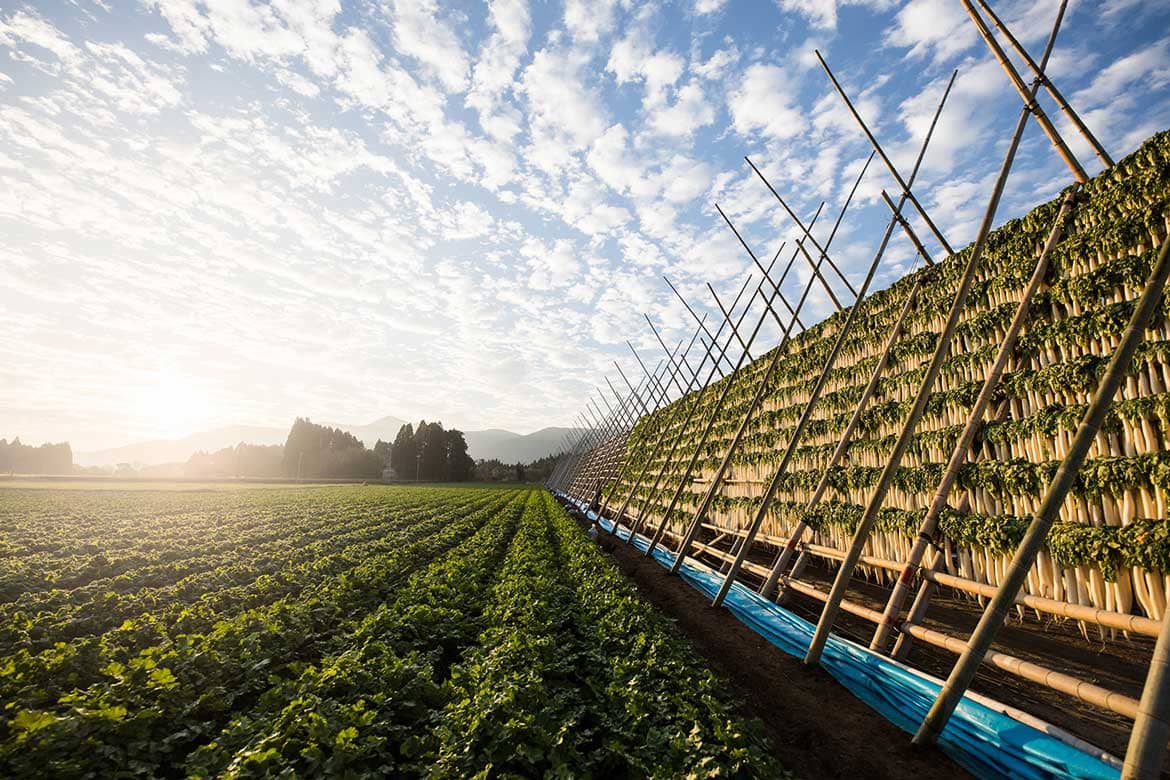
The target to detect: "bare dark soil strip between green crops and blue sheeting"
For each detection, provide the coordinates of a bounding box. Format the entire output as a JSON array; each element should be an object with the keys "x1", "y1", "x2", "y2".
[{"x1": 563, "y1": 502, "x2": 971, "y2": 780}]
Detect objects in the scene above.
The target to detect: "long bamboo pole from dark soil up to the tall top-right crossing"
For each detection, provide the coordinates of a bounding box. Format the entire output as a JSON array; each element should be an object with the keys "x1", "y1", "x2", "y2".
[{"x1": 805, "y1": 28, "x2": 1053, "y2": 664}]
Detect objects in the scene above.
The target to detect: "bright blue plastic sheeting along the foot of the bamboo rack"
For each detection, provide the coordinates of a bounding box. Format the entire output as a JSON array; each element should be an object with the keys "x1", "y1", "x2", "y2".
[{"x1": 560, "y1": 493, "x2": 1121, "y2": 780}]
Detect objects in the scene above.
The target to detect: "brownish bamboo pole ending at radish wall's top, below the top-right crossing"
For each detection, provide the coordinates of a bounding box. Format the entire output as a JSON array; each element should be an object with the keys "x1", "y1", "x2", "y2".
[{"x1": 869, "y1": 187, "x2": 1079, "y2": 651}]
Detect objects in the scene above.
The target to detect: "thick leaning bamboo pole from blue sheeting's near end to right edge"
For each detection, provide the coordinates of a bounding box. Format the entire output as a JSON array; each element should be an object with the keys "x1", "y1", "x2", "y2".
[{"x1": 914, "y1": 237, "x2": 1170, "y2": 748}]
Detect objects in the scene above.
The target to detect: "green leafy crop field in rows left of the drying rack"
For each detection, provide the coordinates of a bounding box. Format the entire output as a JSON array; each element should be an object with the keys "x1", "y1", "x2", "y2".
[{"x1": 0, "y1": 485, "x2": 783, "y2": 778}]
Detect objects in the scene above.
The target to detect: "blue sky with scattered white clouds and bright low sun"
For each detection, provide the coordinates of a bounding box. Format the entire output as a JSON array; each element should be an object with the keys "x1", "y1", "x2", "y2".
[{"x1": 0, "y1": 0, "x2": 1170, "y2": 450}]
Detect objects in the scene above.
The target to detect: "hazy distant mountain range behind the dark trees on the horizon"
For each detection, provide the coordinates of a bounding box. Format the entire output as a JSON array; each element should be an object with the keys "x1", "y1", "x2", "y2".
[{"x1": 74, "y1": 416, "x2": 570, "y2": 467}]
